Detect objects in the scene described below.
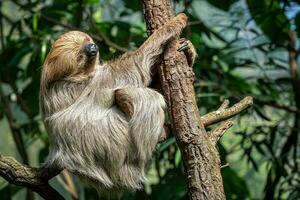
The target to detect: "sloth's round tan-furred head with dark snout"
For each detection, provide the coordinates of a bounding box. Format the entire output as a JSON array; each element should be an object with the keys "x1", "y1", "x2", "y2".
[{"x1": 41, "y1": 31, "x2": 98, "y2": 88}]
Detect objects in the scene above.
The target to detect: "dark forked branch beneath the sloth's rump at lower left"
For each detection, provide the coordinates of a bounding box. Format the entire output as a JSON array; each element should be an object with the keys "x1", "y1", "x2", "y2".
[{"x1": 0, "y1": 154, "x2": 64, "y2": 200}]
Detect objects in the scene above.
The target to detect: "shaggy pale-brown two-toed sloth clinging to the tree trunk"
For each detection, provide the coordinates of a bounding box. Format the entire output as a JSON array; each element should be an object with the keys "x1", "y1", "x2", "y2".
[{"x1": 40, "y1": 14, "x2": 194, "y2": 190}]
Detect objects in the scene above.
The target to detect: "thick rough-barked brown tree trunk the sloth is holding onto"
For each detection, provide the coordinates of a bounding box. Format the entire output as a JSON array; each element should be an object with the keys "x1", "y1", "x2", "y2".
[{"x1": 142, "y1": 0, "x2": 225, "y2": 199}]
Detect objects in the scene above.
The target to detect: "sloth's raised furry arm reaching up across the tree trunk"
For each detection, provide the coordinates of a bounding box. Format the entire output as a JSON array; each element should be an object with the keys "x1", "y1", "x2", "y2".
[{"x1": 109, "y1": 13, "x2": 187, "y2": 86}]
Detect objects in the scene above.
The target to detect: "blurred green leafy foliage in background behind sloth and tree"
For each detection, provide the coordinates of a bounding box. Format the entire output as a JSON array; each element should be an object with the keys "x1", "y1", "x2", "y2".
[{"x1": 0, "y1": 0, "x2": 300, "y2": 200}]
